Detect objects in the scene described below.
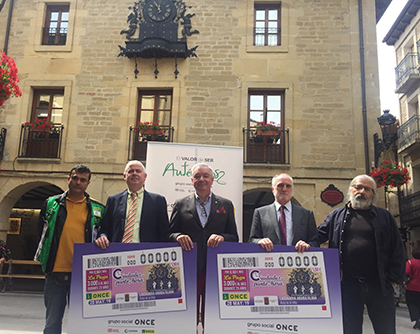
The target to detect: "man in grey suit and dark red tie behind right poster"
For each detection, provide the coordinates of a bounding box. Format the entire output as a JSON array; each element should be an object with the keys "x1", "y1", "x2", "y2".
[{"x1": 249, "y1": 174, "x2": 319, "y2": 253}]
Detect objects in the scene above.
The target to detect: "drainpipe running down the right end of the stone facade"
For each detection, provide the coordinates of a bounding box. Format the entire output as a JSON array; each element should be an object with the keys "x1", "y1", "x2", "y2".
[{"x1": 359, "y1": 0, "x2": 370, "y2": 174}]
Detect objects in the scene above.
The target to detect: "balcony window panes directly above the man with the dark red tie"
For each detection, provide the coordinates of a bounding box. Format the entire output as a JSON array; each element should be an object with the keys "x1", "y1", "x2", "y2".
[{"x1": 249, "y1": 91, "x2": 284, "y2": 129}]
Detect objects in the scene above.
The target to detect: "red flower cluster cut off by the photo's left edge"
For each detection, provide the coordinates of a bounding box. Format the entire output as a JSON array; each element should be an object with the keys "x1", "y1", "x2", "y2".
[{"x1": 0, "y1": 52, "x2": 22, "y2": 106}]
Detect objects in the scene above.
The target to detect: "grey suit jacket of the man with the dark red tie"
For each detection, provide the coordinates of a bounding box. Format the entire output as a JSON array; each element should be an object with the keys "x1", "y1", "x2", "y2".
[{"x1": 249, "y1": 203, "x2": 319, "y2": 247}]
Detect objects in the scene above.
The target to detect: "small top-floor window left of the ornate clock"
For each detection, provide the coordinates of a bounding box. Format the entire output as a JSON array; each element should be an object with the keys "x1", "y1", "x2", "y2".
[{"x1": 42, "y1": 5, "x2": 69, "y2": 45}]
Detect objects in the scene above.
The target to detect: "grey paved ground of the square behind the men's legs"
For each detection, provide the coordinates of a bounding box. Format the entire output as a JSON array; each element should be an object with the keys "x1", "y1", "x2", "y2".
[{"x1": 0, "y1": 291, "x2": 420, "y2": 334}]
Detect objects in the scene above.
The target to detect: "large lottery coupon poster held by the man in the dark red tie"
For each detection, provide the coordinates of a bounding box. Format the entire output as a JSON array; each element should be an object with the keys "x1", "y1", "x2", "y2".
[{"x1": 205, "y1": 243, "x2": 343, "y2": 334}]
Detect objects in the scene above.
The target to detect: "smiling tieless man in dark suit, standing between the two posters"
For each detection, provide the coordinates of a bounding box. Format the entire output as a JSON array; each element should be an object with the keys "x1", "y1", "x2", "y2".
[{"x1": 169, "y1": 164, "x2": 239, "y2": 324}]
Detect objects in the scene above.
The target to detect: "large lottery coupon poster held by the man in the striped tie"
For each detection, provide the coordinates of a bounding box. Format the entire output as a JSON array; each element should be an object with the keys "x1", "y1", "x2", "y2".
[{"x1": 68, "y1": 243, "x2": 197, "y2": 334}]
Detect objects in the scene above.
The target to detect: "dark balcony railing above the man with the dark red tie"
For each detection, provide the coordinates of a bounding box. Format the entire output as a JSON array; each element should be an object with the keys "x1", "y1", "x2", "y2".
[{"x1": 243, "y1": 128, "x2": 290, "y2": 164}]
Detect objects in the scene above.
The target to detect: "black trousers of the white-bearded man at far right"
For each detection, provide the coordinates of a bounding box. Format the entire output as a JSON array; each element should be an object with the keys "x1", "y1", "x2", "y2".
[{"x1": 341, "y1": 278, "x2": 396, "y2": 334}]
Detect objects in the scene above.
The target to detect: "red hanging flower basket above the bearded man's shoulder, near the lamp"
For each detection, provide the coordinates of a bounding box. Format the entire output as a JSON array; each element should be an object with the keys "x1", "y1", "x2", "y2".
[{"x1": 369, "y1": 160, "x2": 411, "y2": 188}]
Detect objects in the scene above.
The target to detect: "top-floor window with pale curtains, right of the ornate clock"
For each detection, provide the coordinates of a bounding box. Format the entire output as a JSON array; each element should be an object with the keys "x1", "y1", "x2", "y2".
[{"x1": 254, "y1": 3, "x2": 281, "y2": 46}]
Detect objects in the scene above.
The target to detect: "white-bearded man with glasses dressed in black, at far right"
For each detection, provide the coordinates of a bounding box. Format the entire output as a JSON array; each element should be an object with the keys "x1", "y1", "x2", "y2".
[{"x1": 318, "y1": 175, "x2": 405, "y2": 334}]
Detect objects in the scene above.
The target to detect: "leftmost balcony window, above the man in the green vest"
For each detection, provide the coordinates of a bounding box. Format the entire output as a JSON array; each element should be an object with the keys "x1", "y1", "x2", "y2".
[{"x1": 31, "y1": 89, "x2": 64, "y2": 125}]
